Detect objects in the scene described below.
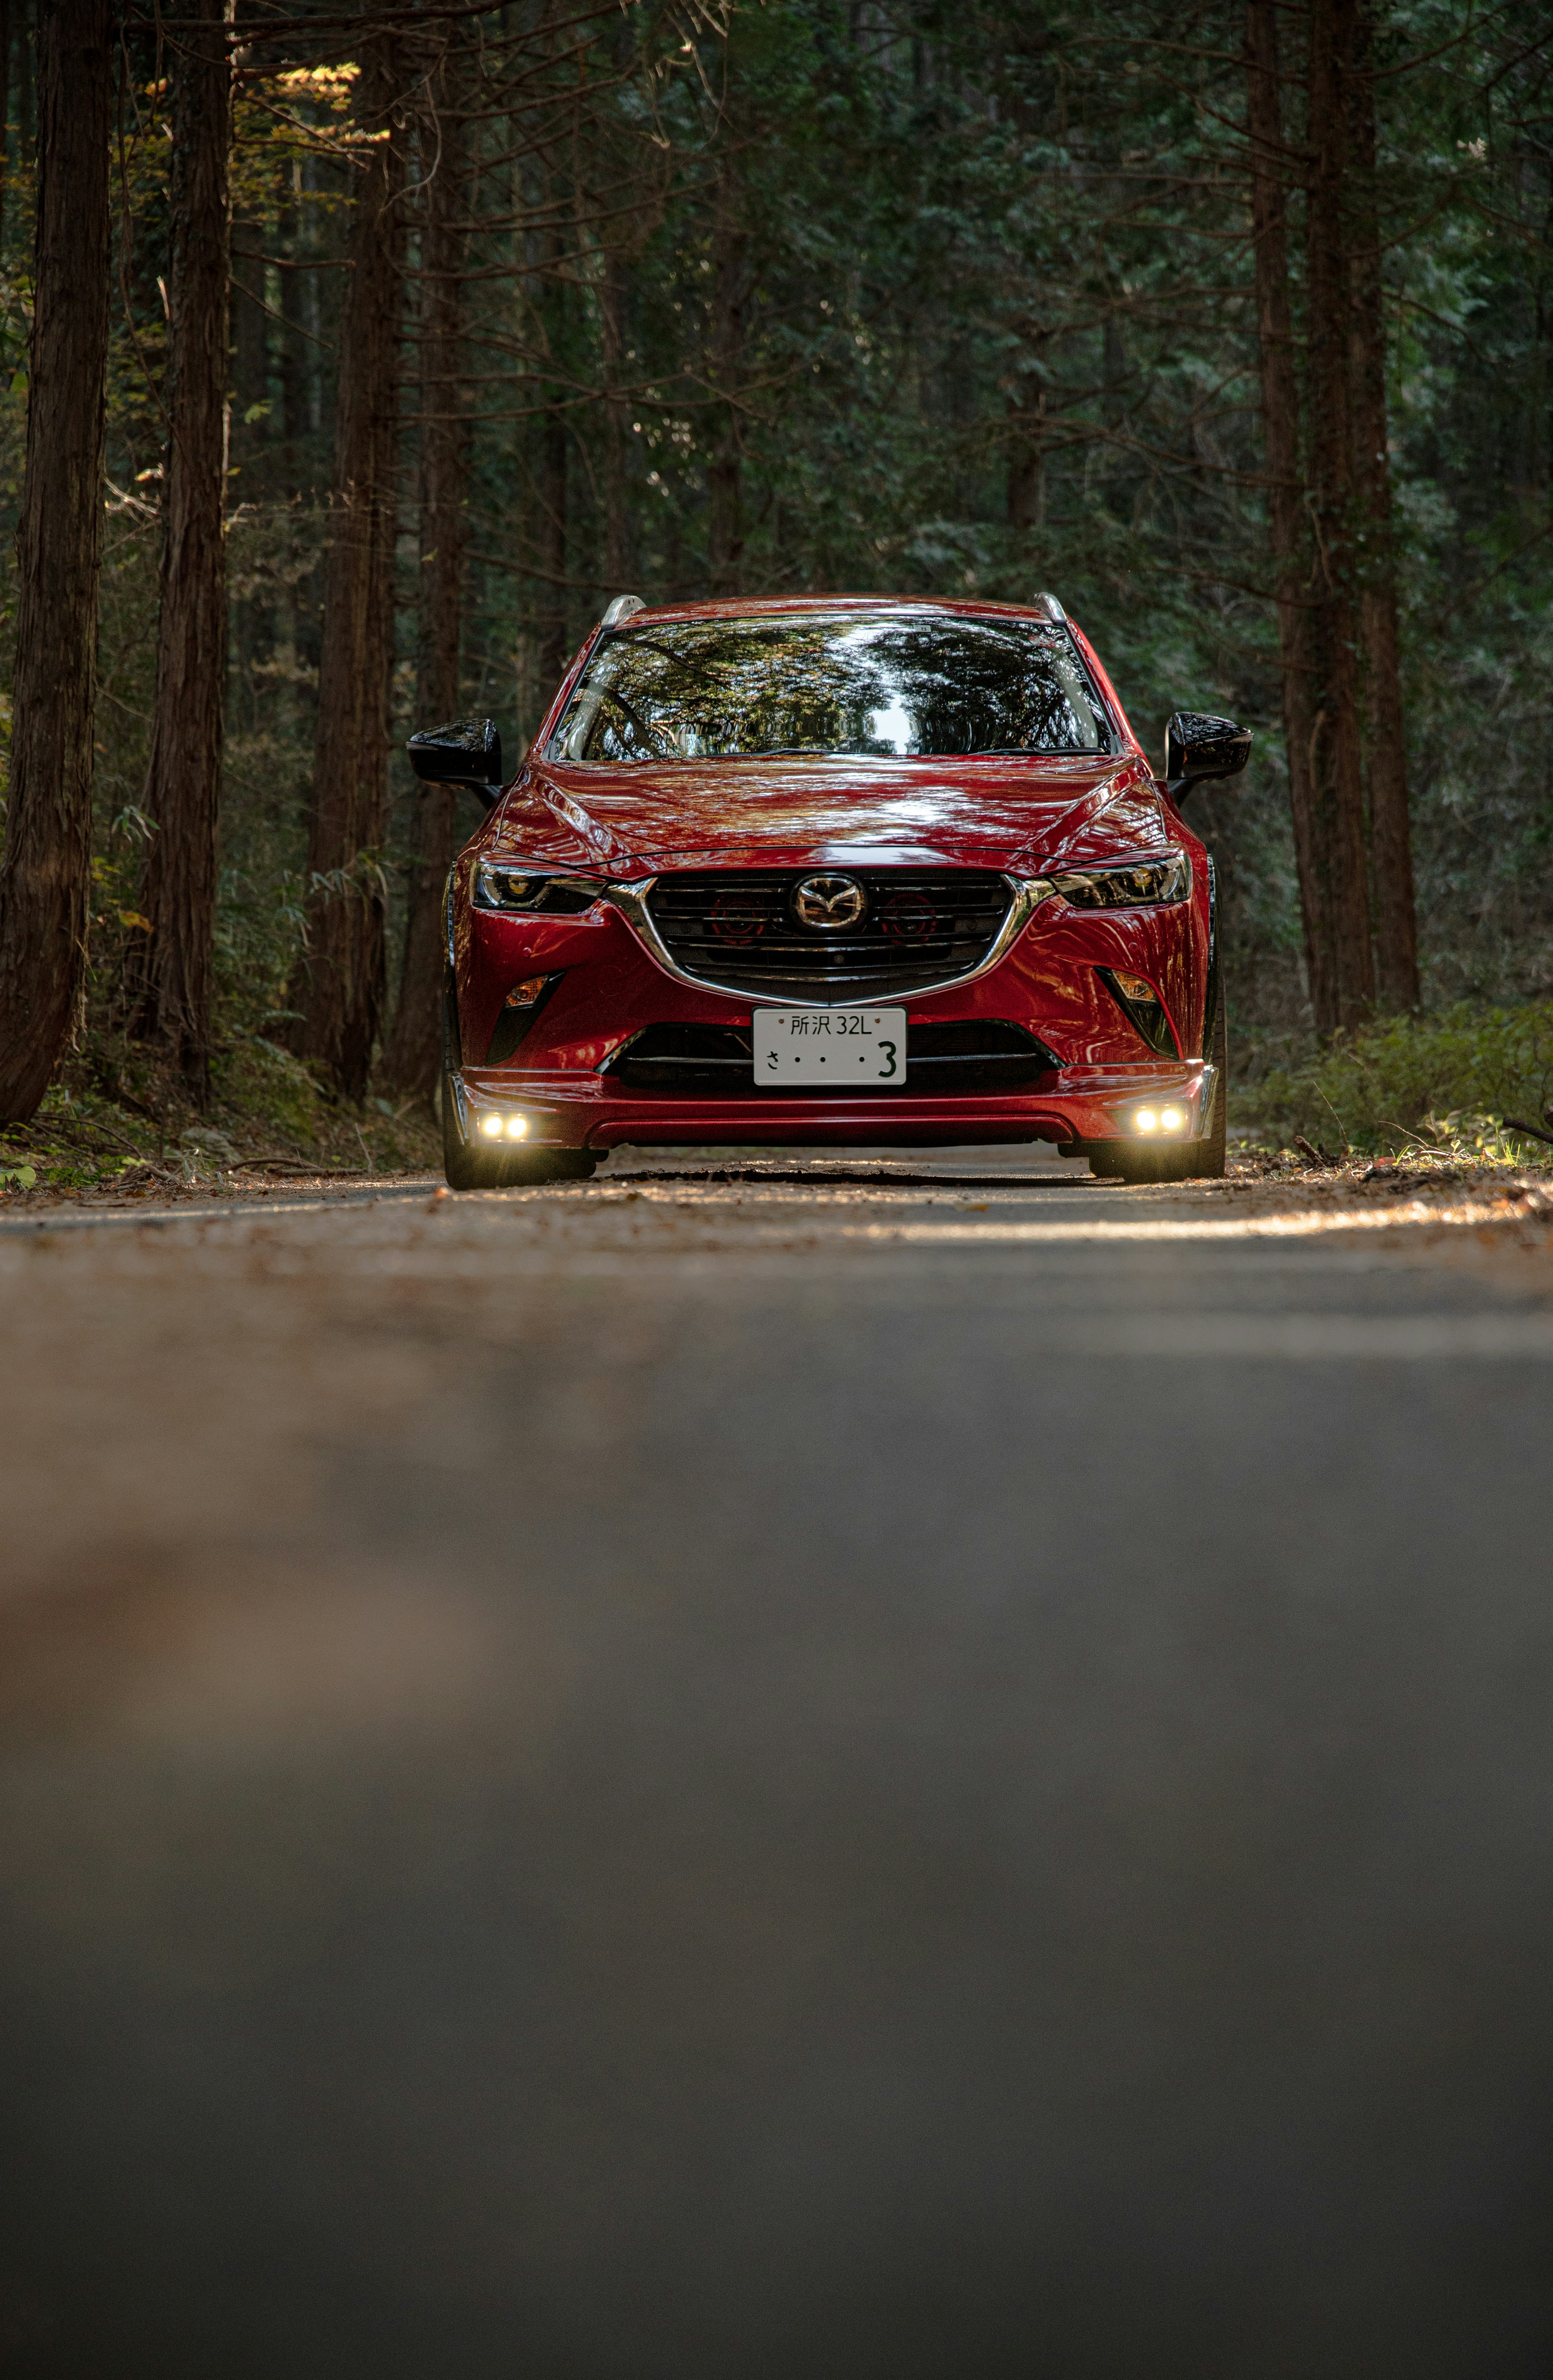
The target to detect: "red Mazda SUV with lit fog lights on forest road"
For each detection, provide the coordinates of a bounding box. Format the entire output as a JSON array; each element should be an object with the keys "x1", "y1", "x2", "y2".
[{"x1": 410, "y1": 595, "x2": 1250, "y2": 1190}]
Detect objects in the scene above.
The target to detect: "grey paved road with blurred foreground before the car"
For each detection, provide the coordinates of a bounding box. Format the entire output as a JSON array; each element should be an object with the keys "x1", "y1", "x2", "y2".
[{"x1": 0, "y1": 1154, "x2": 1553, "y2": 2380}]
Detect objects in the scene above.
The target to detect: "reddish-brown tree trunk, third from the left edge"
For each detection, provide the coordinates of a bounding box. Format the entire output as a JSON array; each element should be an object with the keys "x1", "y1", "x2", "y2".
[{"x1": 298, "y1": 33, "x2": 405, "y2": 1099}]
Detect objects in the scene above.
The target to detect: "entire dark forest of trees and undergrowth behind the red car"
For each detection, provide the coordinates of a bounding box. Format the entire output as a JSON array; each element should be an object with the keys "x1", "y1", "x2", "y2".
[{"x1": 0, "y1": 0, "x2": 1553, "y2": 1180}]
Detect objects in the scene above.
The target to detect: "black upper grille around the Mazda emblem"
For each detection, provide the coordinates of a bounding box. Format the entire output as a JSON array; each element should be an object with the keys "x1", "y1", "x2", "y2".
[{"x1": 648, "y1": 869, "x2": 1012, "y2": 1004}]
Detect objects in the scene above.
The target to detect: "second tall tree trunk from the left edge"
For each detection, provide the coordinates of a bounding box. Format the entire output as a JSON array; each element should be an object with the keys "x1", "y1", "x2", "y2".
[{"x1": 140, "y1": 0, "x2": 231, "y2": 1104}]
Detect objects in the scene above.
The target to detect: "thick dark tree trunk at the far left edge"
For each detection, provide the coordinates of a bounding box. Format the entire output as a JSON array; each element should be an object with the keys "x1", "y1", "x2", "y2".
[{"x1": 0, "y1": 0, "x2": 112, "y2": 1121}]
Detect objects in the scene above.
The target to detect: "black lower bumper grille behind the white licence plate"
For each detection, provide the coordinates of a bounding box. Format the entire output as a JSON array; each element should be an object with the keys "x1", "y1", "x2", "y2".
[{"x1": 605, "y1": 1016, "x2": 1060, "y2": 1099}]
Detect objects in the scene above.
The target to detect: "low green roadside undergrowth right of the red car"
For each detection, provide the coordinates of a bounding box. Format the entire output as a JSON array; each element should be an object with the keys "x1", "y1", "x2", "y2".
[{"x1": 1239, "y1": 1000, "x2": 1553, "y2": 1164}]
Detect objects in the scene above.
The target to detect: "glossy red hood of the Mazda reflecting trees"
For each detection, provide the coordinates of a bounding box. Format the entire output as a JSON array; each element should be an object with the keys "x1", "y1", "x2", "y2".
[{"x1": 479, "y1": 752, "x2": 1172, "y2": 878}]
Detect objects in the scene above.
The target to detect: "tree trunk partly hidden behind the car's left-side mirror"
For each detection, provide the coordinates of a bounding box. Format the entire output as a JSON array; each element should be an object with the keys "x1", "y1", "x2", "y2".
[{"x1": 383, "y1": 56, "x2": 469, "y2": 1095}]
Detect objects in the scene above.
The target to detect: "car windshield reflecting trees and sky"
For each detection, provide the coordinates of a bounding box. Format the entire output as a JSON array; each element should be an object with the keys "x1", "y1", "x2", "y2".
[{"x1": 550, "y1": 612, "x2": 1112, "y2": 762}]
